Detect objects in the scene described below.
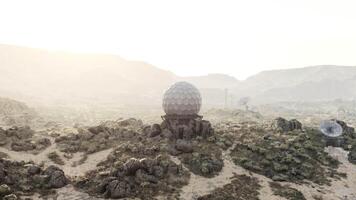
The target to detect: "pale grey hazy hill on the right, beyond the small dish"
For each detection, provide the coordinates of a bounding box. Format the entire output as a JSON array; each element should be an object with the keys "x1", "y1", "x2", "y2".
[{"x1": 239, "y1": 65, "x2": 356, "y2": 102}]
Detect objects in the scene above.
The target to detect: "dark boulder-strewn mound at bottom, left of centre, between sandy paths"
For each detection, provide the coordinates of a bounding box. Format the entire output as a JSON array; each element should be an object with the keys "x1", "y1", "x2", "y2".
[{"x1": 76, "y1": 155, "x2": 189, "y2": 199}]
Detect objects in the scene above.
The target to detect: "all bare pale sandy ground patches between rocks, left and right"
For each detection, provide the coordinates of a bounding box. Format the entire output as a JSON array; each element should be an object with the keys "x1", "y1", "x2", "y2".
[{"x1": 0, "y1": 140, "x2": 356, "y2": 200}]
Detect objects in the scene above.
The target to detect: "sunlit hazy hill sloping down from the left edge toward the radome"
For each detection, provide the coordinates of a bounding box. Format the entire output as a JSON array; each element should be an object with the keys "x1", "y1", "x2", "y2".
[{"x1": 0, "y1": 45, "x2": 177, "y2": 103}]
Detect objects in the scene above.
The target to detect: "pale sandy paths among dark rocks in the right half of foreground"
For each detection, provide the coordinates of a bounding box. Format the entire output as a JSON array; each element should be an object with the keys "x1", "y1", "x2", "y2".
[{"x1": 181, "y1": 147, "x2": 356, "y2": 200}]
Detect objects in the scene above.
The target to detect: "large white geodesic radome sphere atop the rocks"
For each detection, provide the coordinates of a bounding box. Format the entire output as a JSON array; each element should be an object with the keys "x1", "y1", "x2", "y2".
[{"x1": 163, "y1": 82, "x2": 202, "y2": 115}]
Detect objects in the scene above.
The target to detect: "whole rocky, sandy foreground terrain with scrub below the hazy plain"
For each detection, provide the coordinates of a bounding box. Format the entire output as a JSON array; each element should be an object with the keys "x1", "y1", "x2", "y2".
[{"x1": 0, "y1": 113, "x2": 356, "y2": 200}]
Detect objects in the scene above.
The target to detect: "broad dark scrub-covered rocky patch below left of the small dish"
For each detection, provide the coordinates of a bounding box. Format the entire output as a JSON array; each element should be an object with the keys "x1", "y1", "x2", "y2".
[{"x1": 231, "y1": 127, "x2": 344, "y2": 184}]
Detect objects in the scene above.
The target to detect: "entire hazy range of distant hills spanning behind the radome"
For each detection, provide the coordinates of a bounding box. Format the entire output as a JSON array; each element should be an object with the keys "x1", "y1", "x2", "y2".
[{"x1": 0, "y1": 45, "x2": 356, "y2": 106}]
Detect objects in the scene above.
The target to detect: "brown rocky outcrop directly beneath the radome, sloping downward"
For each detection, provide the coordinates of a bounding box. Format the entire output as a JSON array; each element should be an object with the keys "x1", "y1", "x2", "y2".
[{"x1": 160, "y1": 118, "x2": 225, "y2": 177}]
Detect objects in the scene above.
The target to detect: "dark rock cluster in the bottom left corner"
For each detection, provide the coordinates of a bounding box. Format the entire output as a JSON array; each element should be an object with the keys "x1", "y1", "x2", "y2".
[{"x1": 0, "y1": 159, "x2": 69, "y2": 195}]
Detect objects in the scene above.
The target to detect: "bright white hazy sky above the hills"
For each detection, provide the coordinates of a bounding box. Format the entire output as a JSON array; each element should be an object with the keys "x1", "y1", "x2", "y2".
[{"x1": 0, "y1": 0, "x2": 356, "y2": 79}]
